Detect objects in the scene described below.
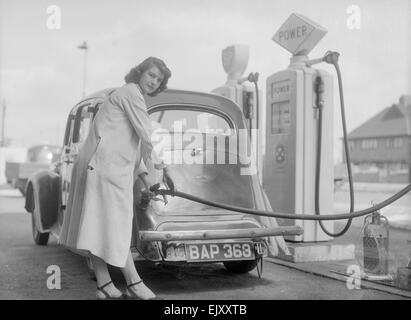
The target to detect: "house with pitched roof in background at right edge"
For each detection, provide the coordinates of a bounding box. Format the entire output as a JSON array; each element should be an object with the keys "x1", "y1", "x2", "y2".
[{"x1": 343, "y1": 95, "x2": 411, "y2": 183}]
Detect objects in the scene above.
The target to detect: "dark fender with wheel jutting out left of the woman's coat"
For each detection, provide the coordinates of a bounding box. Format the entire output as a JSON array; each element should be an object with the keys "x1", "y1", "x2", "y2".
[{"x1": 24, "y1": 170, "x2": 60, "y2": 232}]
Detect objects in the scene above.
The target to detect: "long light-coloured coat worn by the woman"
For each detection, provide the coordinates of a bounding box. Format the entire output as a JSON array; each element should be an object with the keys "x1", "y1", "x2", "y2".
[{"x1": 59, "y1": 83, "x2": 163, "y2": 267}]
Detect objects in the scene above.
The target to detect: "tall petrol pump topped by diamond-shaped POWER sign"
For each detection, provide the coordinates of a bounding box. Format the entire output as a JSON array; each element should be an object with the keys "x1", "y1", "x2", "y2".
[{"x1": 263, "y1": 14, "x2": 333, "y2": 242}]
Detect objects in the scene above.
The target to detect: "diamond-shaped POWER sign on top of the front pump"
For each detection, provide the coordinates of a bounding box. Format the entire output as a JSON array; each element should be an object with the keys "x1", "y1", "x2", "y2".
[{"x1": 272, "y1": 13, "x2": 327, "y2": 55}]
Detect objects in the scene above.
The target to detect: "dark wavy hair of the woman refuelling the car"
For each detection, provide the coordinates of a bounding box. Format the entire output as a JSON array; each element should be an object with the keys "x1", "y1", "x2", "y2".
[{"x1": 124, "y1": 57, "x2": 171, "y2": 96}]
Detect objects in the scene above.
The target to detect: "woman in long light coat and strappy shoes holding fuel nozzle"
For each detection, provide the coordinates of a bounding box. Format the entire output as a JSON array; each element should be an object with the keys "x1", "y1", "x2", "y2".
[{"x1": 59, "y1": 57, "x2": 174, "y2": 299}]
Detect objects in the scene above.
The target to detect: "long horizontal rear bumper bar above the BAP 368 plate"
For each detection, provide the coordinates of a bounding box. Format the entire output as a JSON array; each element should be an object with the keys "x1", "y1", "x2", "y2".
[{"x1": 138, "y1": 226, "x2": 303, "y2": 241}]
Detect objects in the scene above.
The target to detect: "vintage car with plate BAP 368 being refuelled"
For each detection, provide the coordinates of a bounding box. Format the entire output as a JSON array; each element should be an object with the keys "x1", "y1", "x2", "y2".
[{"x1": 25, "y1": 89, "x2": 302, "y2": 272}]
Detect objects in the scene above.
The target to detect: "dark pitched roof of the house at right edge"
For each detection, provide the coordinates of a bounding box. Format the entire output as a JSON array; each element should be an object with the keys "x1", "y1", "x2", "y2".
[{"x1": 348, "y1": 104, "x2": 411, "y2": 139}]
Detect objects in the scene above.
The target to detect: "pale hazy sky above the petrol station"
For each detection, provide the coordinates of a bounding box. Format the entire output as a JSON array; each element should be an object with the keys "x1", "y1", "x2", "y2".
[{"x1": 0, "y1": 0, "x2": 411, "y2": 164}]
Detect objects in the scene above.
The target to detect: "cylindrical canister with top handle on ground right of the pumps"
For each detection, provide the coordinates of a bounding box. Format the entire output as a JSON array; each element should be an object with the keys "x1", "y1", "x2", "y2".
[{"x1": 362, "y1": 211, "x2": 390, "y2": 276}]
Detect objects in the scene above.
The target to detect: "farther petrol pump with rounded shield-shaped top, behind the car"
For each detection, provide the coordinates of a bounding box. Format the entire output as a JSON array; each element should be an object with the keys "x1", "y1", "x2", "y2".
[{"x1": 212, "y1": 44, "x2": 264, "y2": 182}]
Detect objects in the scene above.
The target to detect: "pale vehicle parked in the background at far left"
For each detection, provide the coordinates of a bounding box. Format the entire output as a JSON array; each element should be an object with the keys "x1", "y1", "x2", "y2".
[{"x1": 6, "y1": 144, "x2": 61, "y2": 195}]
